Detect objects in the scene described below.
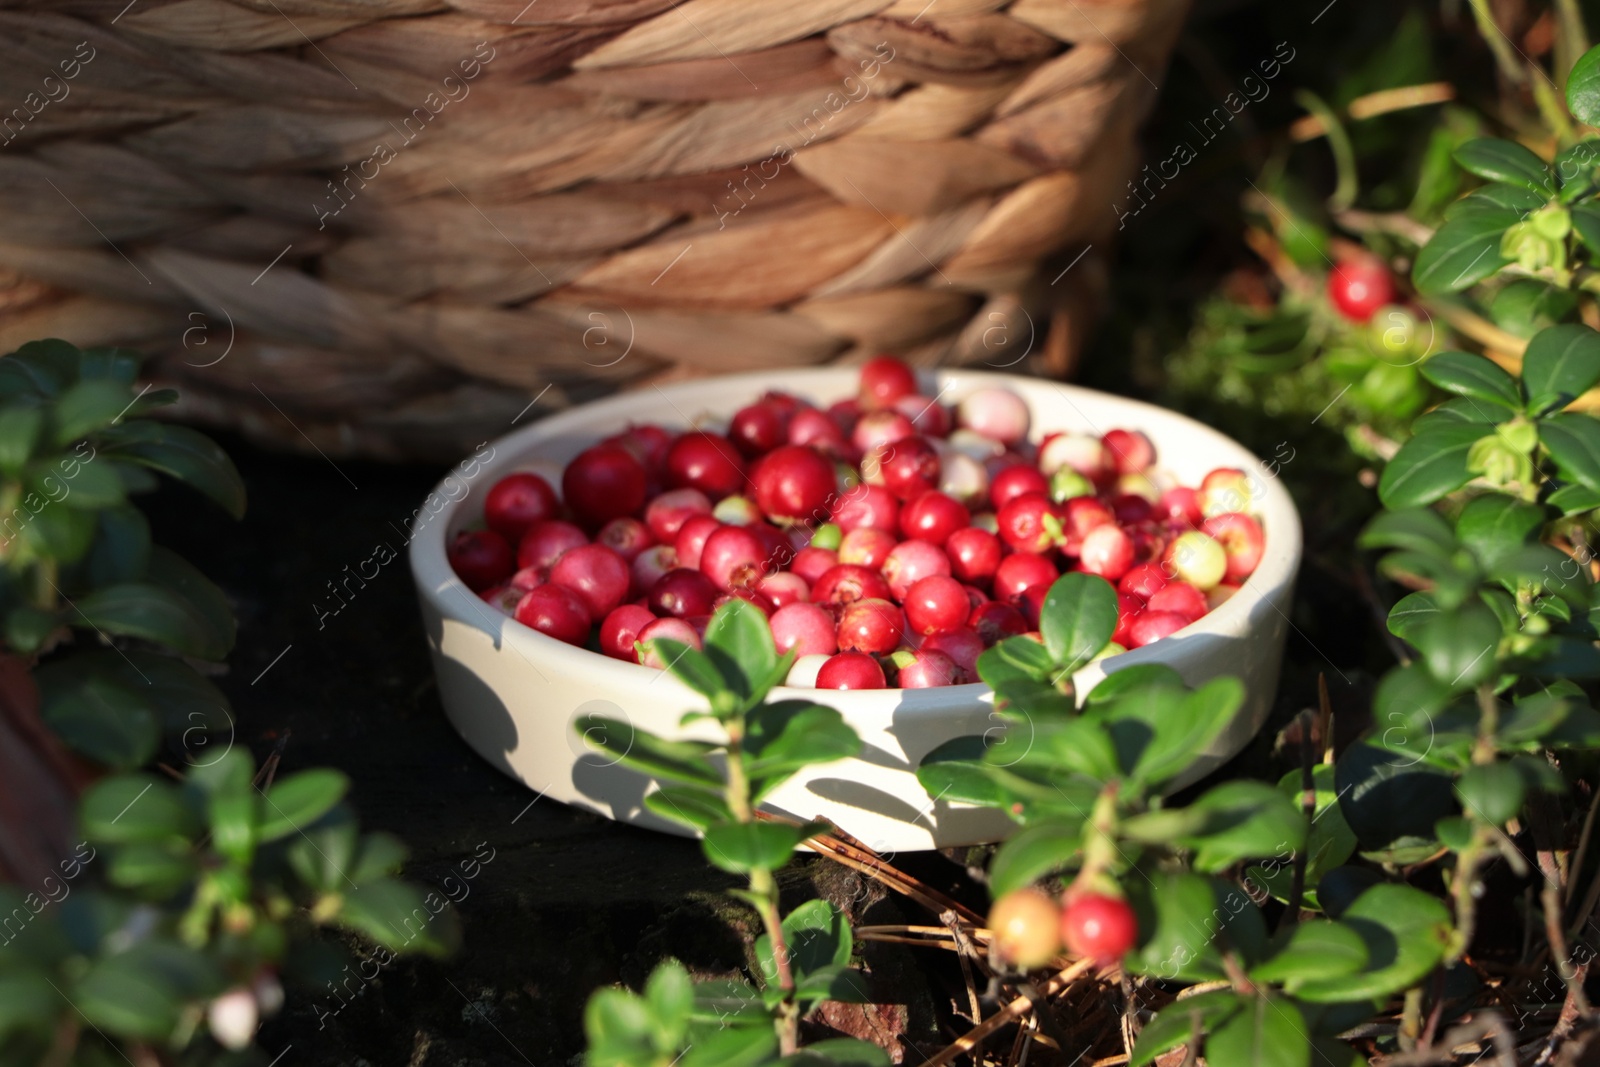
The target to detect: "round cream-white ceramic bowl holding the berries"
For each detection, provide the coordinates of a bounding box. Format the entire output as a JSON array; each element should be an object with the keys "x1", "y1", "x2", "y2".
[{"x1": 411, "y1": 370, "x2": 1301, "y2": 853}]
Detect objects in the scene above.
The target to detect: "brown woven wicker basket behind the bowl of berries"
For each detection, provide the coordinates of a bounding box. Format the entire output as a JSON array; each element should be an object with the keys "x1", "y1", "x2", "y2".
[{"x1": 0, "y1": 0, "x2": 1184, "y2": 456}]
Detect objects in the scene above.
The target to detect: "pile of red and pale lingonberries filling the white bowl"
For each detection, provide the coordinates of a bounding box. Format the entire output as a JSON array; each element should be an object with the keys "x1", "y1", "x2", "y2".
[{"x1": 450, "y1": 357, "x2": 1262, "y2": 689}]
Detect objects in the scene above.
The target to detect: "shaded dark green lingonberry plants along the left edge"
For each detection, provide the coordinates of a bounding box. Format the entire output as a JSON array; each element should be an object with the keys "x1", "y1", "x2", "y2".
[{"x1": 0, "y1": 341, "x2": 454, "y2": 1067}]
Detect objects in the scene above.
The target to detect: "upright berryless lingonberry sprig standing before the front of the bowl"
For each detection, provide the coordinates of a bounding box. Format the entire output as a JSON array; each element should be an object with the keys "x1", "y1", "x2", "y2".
[{"x1": 576, "y1": 600, "x2": 888, "y2": 1067}]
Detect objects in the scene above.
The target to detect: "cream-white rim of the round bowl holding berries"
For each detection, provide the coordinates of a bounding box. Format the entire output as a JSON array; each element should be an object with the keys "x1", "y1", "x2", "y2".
[{"x1": 408, "y1": 366, "x2": 1301, "y2": 712}]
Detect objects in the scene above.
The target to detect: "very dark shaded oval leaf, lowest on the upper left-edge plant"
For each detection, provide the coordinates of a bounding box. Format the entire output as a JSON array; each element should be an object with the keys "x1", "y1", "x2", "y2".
[{"x1": 40, "y1": 675, "x2": 162, "y2": 771}]
